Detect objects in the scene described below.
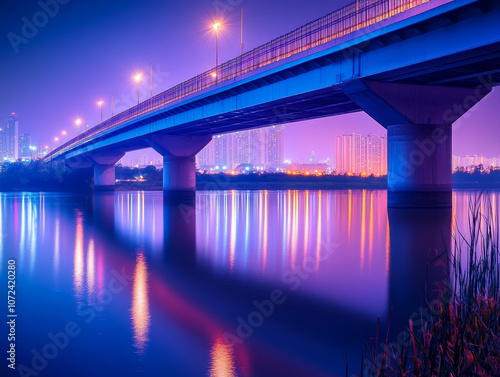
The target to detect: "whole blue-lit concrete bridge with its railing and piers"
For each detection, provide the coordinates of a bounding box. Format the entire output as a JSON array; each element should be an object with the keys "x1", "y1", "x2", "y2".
[{"x1": 45, "y1": 0, "x2": 500, "y2": 206}]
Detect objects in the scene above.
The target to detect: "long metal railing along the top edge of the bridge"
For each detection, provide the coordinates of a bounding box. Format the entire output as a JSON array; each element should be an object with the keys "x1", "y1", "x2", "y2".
[{"x1": 45, "y1": 0, "x2": 430, "y2": 159}]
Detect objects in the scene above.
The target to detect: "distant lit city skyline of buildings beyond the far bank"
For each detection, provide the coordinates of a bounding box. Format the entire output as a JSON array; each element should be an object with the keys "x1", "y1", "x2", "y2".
[{"x1": 6, "y1": 113, "x2": 500, "y2": 175}]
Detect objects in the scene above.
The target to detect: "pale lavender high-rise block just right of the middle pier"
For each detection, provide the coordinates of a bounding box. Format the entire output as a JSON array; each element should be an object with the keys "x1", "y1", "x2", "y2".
[{"x1": 196, "y1": 126, "x2": 284, "y2": 171}]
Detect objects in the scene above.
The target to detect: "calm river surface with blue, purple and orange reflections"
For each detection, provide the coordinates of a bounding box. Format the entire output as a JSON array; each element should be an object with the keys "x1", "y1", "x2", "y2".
[{"x1": 0, "y1": 190, "x2": 500, "y2": 377}]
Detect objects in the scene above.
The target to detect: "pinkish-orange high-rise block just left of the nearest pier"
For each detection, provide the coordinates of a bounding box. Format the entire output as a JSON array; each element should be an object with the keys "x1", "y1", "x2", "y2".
[{"x1": 335, "y1": 132, "x2": 387, "y2": 175}]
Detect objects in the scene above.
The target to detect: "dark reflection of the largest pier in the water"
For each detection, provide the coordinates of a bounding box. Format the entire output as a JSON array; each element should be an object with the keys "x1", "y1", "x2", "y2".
[{"x1": 387, "y1": 207, "x2": 452, "y2": 334}]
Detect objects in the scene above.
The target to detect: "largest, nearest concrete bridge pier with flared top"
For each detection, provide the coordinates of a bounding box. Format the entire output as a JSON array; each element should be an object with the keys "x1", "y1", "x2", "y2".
[{"x1": 344, "y1": 80, "x2": 491, "y2": 207}]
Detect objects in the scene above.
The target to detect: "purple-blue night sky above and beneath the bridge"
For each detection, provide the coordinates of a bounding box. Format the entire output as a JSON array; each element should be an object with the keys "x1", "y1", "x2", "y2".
[{"x1": 0, "y1": 0, "x2": 500, "y2": 161}]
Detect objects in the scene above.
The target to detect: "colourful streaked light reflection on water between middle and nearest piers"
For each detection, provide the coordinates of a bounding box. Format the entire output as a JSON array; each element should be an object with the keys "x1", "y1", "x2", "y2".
[{"x1": 196, "y1": 190, "x2": 389, "y2": 312}]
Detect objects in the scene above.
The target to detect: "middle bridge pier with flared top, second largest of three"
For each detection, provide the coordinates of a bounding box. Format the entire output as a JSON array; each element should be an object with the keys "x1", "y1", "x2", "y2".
[{"x1": 147, "y1": 135, "x2": 212, "y2": 193}]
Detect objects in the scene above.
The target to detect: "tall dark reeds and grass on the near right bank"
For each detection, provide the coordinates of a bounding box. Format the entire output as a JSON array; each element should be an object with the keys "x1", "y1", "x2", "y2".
[{"x1": 354, "y1": 196, "x2": 500, "y2": 377}]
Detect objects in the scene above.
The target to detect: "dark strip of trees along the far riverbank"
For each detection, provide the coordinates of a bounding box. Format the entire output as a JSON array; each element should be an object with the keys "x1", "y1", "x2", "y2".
[{"x1": 0, "y1": 160, "x2": 500, "y2": 191}]
